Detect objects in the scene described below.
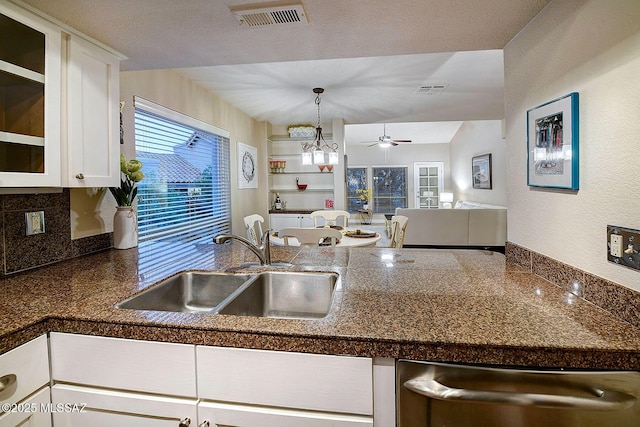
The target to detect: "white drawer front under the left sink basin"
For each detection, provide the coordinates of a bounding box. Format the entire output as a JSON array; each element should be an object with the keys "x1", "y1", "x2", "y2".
[{"x1": 51, "y1": 333, "x2": 196, "y2": 397}]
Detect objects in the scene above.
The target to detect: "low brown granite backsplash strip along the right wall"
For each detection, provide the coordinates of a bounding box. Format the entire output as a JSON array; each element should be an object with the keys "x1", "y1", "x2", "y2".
[{"x1": 505, "y1": 242, "x2": 640, "y2": 327}]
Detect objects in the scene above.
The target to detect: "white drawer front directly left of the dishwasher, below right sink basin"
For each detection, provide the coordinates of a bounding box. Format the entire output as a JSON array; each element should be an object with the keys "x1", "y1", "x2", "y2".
[{"x1": 196, "y1": 346, "x2": 373, "y2": 415}]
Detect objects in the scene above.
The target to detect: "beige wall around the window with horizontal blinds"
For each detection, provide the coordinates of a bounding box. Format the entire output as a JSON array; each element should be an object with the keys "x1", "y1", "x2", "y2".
[{"x1": 71, "y1": 70, "x2": 269, "y2": 239}]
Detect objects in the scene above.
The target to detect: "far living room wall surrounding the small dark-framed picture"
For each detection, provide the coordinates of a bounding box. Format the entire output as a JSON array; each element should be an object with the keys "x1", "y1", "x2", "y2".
[{"x1": 449, "y1": 120, "x2": 507, "y2": 206}]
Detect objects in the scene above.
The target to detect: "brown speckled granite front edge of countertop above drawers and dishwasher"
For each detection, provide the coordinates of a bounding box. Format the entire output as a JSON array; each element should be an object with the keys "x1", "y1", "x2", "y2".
[{"x1": 0, "y1": 318, "x2": 640, "y2": 370}]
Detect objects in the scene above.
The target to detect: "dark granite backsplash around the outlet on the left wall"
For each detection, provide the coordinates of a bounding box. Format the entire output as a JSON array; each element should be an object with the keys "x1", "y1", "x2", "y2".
[{"x1": 0, "y1": 188, "x2": 113, "y2": 275}]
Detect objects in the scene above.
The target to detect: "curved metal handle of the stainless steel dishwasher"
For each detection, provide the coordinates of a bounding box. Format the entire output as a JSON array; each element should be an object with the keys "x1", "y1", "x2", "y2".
[{"x1": 404, "y1": 378, "x2": 636, "y2": 411}]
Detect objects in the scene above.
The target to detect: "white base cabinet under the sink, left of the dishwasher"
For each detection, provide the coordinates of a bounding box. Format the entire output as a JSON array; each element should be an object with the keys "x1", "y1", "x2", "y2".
[{"x1": 47, "y1": 332, "x2": 394, "y2": 427}]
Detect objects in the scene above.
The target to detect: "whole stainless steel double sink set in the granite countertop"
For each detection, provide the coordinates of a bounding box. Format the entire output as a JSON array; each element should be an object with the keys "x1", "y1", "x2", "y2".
[{"x1": 116, "y1": 271, "x2": 339, "y2": 319}]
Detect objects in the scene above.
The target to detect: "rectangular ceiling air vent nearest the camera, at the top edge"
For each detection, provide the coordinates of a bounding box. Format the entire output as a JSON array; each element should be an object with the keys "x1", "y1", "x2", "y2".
[{"x1": 230, "y1": 2, "x2": 309, "y2": 27}]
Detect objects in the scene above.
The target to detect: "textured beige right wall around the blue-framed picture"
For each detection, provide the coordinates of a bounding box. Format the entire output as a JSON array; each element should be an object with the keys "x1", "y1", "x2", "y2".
[{"x1": 504, "y1": 0, "x2": 640, "y2": 290}]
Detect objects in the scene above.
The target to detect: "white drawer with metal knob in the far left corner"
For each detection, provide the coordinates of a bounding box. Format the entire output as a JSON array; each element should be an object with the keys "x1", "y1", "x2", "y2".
[{"x1": 0, "y1": 335, "x2": 49, "y2": 403}]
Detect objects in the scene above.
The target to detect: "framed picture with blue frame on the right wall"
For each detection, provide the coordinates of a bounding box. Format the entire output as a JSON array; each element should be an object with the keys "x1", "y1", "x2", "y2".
[{"x1": 527, "y1": 92, "x2": 580, "y2": 190}]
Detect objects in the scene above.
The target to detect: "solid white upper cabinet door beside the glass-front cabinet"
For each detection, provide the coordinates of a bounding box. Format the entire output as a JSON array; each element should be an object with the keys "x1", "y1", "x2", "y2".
[{"x1": 63, "y1": 35, "x2": 120, "y2": 187}]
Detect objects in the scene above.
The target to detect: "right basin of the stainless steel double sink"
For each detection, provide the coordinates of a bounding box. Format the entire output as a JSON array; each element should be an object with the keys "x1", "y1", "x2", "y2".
[{"x1": 218, "y1": 271, "x2": 339, "y2": 319}]
